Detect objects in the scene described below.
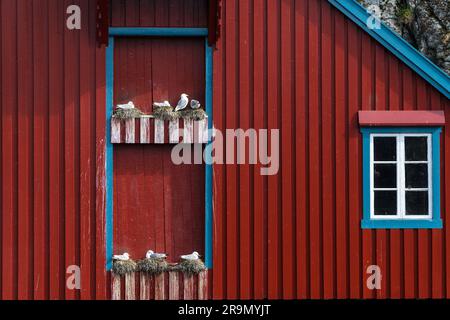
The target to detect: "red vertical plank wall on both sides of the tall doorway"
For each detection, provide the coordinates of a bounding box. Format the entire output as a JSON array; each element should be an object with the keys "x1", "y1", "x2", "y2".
[{"x1": 0, "y1": 0, "x2": 450, "y2": 299}]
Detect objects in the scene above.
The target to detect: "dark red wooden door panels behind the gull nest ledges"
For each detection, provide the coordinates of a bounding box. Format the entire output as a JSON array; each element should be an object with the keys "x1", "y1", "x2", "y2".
[{"x1": 114, "y1": 38, "x2": 205, "y2": 261}]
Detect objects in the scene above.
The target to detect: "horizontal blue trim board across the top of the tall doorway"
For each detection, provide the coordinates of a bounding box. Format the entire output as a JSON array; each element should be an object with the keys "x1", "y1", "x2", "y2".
[{"x1": 109, "y1": 28, "x2": 208, "y2": 37}]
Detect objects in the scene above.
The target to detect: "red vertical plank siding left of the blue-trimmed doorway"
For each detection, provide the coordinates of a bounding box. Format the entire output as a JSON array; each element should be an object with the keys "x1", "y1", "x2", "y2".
[{"x1": 0, "y1": 0, "x2": 109, "y2": 299}]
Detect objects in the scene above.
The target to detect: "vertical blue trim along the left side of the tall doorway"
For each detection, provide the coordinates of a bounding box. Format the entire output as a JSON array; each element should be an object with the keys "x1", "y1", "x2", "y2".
[{"x1": 105, "y1": 37, "x2": 114, "y2": 271}]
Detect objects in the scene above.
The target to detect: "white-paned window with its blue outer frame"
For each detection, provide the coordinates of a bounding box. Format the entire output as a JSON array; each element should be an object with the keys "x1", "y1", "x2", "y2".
[{"x1": 361, "y1": 127, "x2": 442, "y2": 229}]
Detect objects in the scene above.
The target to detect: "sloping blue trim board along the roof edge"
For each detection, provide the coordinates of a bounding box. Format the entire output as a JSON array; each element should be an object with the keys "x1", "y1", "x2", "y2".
[{"x1": 328, "y1": 0, "x2": 450, "y2": 99}]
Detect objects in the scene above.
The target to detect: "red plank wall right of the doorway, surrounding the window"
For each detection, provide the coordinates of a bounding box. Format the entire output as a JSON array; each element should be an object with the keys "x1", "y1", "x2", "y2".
[{"x1": 213, "y1": 0, "x2": 450, "y2": 299}]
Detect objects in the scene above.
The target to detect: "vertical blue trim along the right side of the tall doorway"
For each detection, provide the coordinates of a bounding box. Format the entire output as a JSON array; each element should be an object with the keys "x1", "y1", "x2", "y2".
[{"x1": 205, "y1": 39, "x2": 213, "y2": 269}]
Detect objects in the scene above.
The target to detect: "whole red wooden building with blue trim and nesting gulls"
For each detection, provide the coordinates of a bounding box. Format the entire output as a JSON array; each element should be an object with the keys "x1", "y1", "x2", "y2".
[{"x1": 0, "y1": 0, "x2": 450, "y2": 299}]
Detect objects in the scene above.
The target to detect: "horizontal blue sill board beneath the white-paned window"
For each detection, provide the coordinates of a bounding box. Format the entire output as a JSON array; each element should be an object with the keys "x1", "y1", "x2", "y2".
[{"x1": 361, "y1": 219, "x2": 443, "y2": 229}]
